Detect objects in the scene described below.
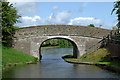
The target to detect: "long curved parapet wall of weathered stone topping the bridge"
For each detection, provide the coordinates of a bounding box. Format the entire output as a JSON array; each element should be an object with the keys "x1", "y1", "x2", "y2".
[{"x1": 15, "y1": 25, "x2": 114, "y2": 38}]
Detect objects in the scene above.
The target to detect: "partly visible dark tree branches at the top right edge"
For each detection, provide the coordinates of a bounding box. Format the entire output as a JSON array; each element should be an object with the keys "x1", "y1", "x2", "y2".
[{"x1": 111, "y1": 1, "x2": 120, "y2": 33}]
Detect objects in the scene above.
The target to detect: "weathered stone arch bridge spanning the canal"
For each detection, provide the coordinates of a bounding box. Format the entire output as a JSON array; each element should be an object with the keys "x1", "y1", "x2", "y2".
[{"x1": 12, "y1": 25, "x2": 113, "y2": 58}]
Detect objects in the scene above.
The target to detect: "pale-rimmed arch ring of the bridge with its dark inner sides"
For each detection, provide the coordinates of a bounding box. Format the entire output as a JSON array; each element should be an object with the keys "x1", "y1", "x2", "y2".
[{"x1": 39, "y1": 36, "x2": 79, "y2": 59}]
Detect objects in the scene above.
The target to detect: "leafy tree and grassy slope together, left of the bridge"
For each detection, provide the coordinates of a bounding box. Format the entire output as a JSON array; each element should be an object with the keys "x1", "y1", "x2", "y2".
[{"x1": 0, "y1": 1, "x2": 38, "y2": 68}]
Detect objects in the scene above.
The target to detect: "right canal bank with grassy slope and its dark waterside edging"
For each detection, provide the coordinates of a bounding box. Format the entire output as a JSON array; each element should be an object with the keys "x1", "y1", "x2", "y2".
[{"x1": 62, "y1": 48, "x2": 120, "y2": 73}]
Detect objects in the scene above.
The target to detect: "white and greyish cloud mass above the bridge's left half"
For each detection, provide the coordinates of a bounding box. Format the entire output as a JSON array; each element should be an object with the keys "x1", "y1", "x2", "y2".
[{"x1": 16, "y1": 11, "x2": 71, "y2": 27}]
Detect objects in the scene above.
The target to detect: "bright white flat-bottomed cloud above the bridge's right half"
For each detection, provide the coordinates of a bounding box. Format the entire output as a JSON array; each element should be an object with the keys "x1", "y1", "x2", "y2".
[{"x1": 68, "y1": 17, "x2": 103, "y2": 26}]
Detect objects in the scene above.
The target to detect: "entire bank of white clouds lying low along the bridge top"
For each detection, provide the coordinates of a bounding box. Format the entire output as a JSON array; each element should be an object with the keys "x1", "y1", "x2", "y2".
[{"x1": 18, "y1": 12, "x2": 105, "y2": 27}]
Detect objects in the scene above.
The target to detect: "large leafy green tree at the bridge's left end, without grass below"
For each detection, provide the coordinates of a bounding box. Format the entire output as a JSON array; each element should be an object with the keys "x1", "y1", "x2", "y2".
[{"x1": 1, "y1": 2, "x2": 21, "y2": 46}]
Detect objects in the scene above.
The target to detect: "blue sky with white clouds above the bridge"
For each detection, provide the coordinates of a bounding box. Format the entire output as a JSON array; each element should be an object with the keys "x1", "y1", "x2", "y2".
[{"x1": 7, "y1": 1, "x2": 117, "y2": 29}]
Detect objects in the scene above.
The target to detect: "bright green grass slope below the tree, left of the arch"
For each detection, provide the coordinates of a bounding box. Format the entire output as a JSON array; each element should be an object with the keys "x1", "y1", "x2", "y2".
[{"x1": 2, "y1": 46, "x2": 38, "y2": 67}]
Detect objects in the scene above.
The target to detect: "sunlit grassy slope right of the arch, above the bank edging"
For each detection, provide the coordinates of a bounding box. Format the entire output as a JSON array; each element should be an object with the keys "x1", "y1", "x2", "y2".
[{"x1": 64, "y1": 48, "x2": 120, "y2": 67}]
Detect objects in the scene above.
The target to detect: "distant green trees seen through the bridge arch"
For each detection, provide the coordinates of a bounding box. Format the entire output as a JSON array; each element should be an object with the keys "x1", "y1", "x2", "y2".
[{"x1": 41, "y1": 39, "x2": 72, "y2": 48}]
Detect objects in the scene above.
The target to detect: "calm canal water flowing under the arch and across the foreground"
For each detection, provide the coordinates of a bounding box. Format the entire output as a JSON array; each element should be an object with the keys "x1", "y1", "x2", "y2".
[{"x1": 3, "y1": 48, "x2": 120, "y2": 78}]
